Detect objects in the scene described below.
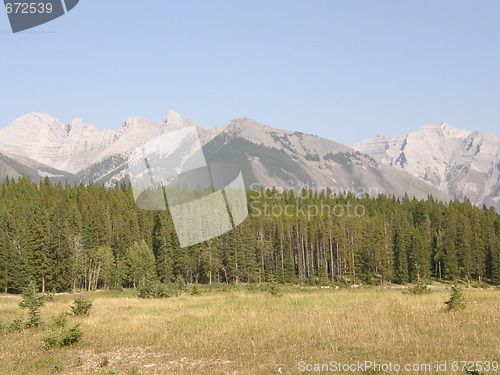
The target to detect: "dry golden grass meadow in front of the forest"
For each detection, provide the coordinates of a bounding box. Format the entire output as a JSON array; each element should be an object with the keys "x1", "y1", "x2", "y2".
[{"x1": 0, "y1": 287, "x2": 500, "y2": 375}]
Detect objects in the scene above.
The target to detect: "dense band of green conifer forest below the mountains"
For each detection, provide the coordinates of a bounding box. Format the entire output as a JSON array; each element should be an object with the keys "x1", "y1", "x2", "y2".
[{"x1": 0, "y1": 179, "x2": 500, "y2": 293}]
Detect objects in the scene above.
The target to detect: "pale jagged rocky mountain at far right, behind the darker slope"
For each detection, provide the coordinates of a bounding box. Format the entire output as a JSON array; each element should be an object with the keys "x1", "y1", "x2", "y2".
[{"x1": 353, "y1": 122, "x2": 500, "y2": 207}]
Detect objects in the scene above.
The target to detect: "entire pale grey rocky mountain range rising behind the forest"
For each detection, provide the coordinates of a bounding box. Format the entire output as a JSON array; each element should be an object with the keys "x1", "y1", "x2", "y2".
[{"x1": 0, "y1": 110, "x2": 500, "y2": 208}]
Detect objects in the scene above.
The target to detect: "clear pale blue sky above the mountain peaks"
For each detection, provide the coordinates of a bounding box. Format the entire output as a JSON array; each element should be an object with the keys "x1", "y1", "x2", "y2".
[{"x1": 0, "y1": 0, "x2": 500, "y2": 145}]
